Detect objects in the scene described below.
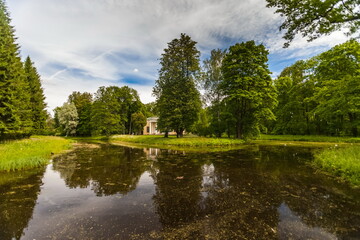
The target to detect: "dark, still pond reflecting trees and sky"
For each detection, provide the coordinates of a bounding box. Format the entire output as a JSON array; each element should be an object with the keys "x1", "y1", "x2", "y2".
[{"x1": 0, "y1": 143, "x2": 360, "y2": 240}]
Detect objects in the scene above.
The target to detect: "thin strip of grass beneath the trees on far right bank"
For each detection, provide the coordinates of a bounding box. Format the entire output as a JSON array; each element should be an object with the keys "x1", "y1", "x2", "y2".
[{"x1": 259, "y1": 134, "x2": 360, "y2": 143}]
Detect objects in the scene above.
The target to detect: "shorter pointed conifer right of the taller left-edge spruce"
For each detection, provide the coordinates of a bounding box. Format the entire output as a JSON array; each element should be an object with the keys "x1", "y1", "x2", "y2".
[{"x1": 24, "y1": 56, "x2": 47, "y2": 133}]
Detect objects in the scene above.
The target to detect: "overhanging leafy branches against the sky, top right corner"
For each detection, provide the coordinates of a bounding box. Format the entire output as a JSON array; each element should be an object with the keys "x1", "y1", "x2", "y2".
[{"x1": 266, "y1": 0, "x2": 360, "y2": 47}]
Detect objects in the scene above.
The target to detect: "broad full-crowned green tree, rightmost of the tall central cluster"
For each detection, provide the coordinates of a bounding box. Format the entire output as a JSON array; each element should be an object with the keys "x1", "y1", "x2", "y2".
[{"x1": 220, "y1": 41, "x2": 277, "y2": 139}]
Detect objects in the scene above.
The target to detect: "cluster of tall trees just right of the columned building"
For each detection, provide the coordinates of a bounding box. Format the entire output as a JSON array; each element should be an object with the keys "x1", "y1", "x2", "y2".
[{"x1": 153, "y1": 34, "x2": 277, "y2": 138}]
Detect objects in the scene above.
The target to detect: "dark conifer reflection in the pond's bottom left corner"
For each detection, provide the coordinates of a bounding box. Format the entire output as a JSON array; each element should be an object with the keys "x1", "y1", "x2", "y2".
[{"x1": 0, "y1": 169, "x2": 44, "y2": 240}]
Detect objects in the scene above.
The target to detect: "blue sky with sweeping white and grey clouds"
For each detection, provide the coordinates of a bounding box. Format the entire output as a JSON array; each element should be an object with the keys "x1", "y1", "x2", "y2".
[{"x1": 7, "y1": 0, "x2": 347, "y2": 113}]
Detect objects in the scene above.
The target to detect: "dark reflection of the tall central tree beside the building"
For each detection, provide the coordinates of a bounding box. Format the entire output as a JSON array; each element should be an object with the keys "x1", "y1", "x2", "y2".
[{"x1": 153, "y1": 150, "x2": 202, "y2": 227}]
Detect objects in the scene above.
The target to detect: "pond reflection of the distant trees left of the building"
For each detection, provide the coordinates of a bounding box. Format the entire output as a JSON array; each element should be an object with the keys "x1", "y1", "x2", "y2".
[{"x1": 53, "y1": 144, "x2": 149, "y2": 196}]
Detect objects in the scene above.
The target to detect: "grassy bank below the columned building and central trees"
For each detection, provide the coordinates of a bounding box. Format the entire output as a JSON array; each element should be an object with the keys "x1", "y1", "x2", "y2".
[{"x1": 109, "y1": 135, "x2": 244, "y2": 147}]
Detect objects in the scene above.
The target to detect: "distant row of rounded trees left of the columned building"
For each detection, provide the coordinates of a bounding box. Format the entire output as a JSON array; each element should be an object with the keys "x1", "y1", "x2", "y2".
[{"x1": 54, "y1": 86, "x2": 152, "y2": 136}]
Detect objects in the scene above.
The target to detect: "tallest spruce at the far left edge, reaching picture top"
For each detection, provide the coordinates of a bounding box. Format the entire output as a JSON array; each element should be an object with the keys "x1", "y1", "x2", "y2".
[{"x1": 0, "y1": 0, "x2": 32, "y2": 139}]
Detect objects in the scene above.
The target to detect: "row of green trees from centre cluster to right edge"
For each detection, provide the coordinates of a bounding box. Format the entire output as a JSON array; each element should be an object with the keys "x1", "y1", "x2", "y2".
[{"x1": 194, "y1": 40, "x2": 360, "y2": 138}]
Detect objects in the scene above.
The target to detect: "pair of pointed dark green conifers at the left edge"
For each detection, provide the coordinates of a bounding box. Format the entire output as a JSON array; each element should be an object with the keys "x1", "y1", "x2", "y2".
[{"x1": 0, "y1": 0, "x2": 47, "y2": 141}]
